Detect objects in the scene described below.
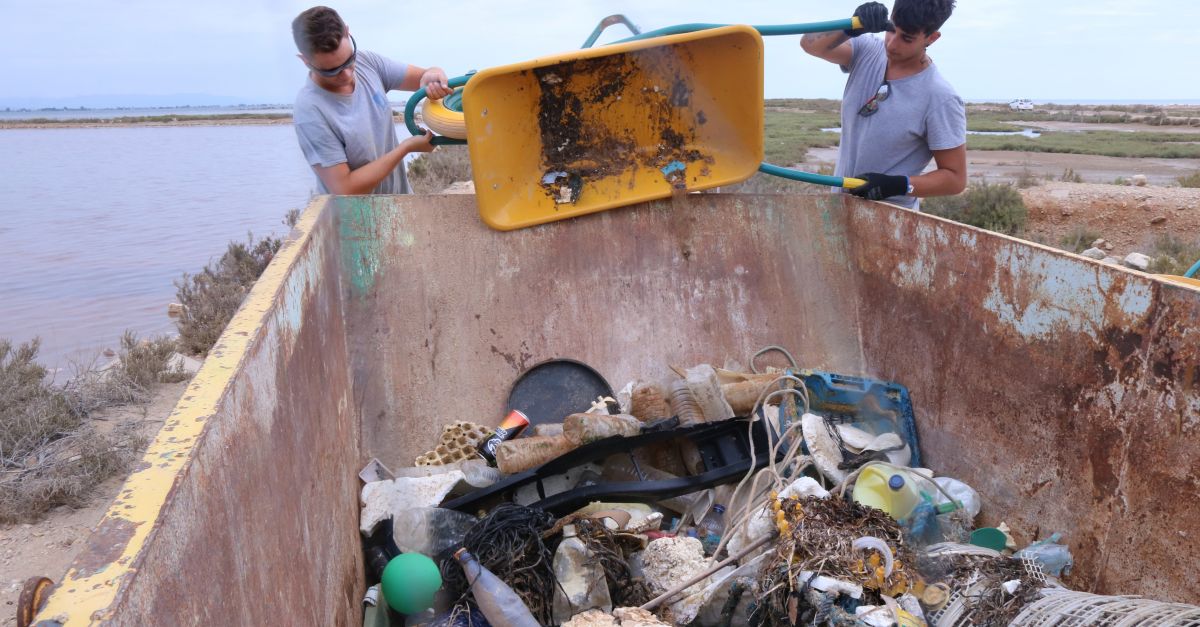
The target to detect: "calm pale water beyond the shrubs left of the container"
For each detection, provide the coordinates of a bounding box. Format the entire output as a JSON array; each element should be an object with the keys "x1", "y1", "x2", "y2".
[{"x1": 0, "y1": 124, "x2": 338, "y2": 368}]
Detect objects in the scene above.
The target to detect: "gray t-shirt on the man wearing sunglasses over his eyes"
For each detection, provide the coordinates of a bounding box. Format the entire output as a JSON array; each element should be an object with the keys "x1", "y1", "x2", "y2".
[{"x1": 292, "y1": 50, "x2": 412, "y2": 193}]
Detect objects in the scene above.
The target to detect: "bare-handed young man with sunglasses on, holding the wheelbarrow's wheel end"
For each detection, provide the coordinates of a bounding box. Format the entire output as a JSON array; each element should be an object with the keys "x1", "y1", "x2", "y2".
[{"x1": 292, "y1": 6, "x2": 451, "y2": 195}]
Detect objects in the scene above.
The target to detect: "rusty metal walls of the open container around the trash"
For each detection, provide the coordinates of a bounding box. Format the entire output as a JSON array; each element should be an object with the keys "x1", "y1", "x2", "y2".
[{"x1": 32, "y1": 195, "x2": 1200, "y2": 625}]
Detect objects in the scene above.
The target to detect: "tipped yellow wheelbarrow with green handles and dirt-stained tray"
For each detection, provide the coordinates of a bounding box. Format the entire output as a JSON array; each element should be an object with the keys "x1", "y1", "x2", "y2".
[{"x1": 404, "y1": 16, "x2": 862, "y2": 231}]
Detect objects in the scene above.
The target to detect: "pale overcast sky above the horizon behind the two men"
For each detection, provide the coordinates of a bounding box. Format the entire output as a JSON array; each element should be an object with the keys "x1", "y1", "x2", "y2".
[{"x1": 0, "y1": 0, "x2": 1200, "y2": 105}]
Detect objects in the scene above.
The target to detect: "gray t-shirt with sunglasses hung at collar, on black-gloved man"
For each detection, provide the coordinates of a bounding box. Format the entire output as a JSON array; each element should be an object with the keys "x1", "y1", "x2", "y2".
[{"x1": 835, "y1": 35, "x2": 967, "y2": 209}]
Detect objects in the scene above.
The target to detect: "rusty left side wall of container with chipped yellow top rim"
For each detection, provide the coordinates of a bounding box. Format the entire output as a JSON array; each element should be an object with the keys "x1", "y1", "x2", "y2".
[{"x1": 37, "y1": 202, "x2": 364, "y2": 626}]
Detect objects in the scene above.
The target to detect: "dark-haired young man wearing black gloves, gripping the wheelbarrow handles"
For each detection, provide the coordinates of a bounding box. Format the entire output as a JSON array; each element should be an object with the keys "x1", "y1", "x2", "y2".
[{"x1": 800, "y1": 0, "x2": 967, "y2": 209}]
